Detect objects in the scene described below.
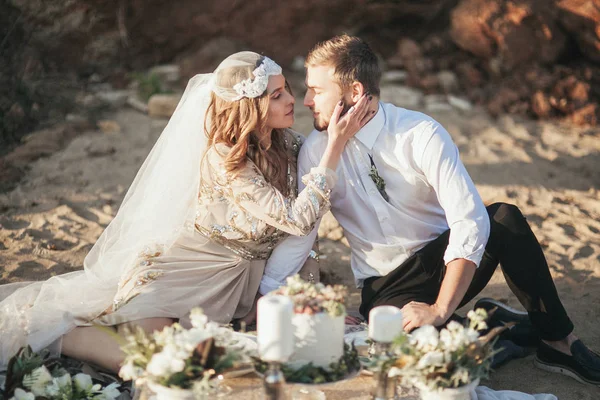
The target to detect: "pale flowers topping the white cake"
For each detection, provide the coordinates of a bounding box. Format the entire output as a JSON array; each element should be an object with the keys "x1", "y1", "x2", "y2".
[{"x1": 272, "y1": 275, "x2": 348, "y2": 317}]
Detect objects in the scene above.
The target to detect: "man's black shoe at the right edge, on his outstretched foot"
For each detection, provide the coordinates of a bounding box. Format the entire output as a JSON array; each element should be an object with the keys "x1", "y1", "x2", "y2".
[{"x1": 534, "y1": 340, "x2": 600, "y2": 387}]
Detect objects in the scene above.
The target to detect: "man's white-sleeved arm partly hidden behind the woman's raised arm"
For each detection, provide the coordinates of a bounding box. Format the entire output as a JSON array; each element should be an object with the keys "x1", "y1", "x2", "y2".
[{"x1": 259, "y1": 131, "x2": 321, "y2": 294}]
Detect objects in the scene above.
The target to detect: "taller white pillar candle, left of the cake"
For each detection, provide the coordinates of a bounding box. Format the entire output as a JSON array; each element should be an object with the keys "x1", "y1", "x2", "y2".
[{"x1": 256, "y1": 296, "x2": 294, "y2": 362}]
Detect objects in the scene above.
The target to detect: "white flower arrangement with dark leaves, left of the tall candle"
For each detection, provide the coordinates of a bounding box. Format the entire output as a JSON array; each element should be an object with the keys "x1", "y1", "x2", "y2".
[{"x1": 119, "y1": 308, "x2": 243, "y2": 393}]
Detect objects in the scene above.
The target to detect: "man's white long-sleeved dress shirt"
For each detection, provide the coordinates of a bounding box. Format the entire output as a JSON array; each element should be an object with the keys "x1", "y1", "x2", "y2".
[{"x1": 260, "y1": 102, "x2": 490, "y2": 294}]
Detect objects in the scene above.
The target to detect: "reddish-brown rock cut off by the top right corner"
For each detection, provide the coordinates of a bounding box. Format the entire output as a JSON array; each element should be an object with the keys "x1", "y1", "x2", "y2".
[{"x1": 556, "y1": 0, "x2": 600, "y2": 63}]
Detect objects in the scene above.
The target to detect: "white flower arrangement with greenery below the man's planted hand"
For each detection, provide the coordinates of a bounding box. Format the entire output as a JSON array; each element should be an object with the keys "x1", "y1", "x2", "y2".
[{"x1": 382, "y1": 309, "x2": 505, "y2": 390}]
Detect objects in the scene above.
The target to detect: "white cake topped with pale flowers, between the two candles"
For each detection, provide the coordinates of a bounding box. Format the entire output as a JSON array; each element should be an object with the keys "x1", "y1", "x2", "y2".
[{"x1": 275, "y1": 275, "x2": 347, "y2": 369}]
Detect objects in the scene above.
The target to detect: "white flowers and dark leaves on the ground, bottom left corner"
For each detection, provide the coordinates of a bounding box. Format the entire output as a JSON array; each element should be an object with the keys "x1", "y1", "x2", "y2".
[{"x1": 0, "y1": 347, "x2": 121, "y2": 400}]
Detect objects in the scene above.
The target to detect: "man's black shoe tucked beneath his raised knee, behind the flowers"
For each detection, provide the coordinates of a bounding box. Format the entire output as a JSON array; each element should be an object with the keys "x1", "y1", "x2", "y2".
[{"x1": 473, "y1": 297, "x2": 540, "y2": 347}]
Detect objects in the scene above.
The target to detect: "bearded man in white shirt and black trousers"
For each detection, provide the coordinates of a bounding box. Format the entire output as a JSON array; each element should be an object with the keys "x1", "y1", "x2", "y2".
[{"x1": 260, "y1": 35, "x2": 600, "y2": 385}]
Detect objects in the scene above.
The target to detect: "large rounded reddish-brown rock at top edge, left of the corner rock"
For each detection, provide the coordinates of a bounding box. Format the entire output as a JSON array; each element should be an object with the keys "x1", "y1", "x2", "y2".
[{"x1": 450, "y1": 0, "x2": 567, "y2": 71}]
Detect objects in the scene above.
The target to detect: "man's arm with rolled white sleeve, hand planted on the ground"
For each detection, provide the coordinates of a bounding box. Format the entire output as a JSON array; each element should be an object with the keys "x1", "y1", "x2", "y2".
[{"x1": 403, "y1": 122, "x2": 490, "y2": 330}]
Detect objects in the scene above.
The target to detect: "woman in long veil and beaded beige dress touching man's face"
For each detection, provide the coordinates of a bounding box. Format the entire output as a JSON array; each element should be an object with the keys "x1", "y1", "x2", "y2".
[{"x1": 0, "y1": 52, "x2": 368, "y2": 371}]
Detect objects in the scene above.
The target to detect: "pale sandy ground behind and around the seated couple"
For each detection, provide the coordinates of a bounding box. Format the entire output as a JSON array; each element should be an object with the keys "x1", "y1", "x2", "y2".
[{"x1": 0, "y1": 79, "x2": 600, "y2": 400}]
